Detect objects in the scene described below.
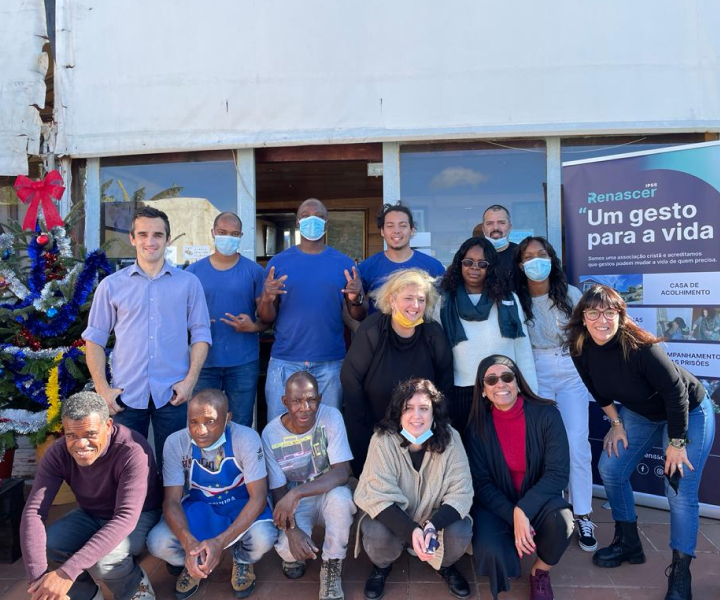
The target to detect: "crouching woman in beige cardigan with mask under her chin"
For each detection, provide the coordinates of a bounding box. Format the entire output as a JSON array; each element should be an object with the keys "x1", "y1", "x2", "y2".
[{"x1": 355, "y1": 378, "x2": 473, "y2": 600}]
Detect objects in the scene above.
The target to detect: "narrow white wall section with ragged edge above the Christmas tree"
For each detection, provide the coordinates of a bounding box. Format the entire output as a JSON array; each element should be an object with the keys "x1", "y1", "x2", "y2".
[{"x1": 0, "y1": 0, "x2": 48, "y2": 176}]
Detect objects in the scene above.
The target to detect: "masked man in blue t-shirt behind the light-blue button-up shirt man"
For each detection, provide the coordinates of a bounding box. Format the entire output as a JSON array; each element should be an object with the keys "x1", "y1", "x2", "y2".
[{"x1": 187, "y1": 212, "x2": 268, "y2": 427}]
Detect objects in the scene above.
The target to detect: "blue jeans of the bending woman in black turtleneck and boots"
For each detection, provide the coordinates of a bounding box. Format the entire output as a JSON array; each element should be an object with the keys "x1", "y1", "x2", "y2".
[{"x1": 598, "y1": 396, "x2": 715, "y2": 556}]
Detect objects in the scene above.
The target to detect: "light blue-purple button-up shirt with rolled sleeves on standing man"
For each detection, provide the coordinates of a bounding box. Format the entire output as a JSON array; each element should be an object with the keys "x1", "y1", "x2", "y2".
[{"x1": 82, "y1": 263, "x2": 212, "y2": 408}]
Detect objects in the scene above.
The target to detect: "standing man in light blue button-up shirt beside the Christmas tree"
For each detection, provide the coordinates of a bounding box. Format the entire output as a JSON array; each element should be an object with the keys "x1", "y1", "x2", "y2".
[{"x1": 83, "y1": 207, "x2": 211, "y2": 468}]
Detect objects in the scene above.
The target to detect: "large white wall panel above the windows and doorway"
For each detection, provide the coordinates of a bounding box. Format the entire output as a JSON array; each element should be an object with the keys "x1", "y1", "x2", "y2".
[{"x1": 56, "y1": 0, "x2": 720, "y2": 156}]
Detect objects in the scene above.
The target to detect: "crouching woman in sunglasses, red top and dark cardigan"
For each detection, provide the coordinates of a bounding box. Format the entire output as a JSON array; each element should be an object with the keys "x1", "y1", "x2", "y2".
[{"x1": 467, "y1": 354, "x2": 573, "y2": 600}]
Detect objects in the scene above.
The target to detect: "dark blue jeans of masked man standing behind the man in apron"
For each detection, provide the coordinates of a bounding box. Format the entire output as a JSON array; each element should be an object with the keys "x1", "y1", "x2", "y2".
[{"x1": 193, "y1": 360, "x2": 260, "y2": 427}]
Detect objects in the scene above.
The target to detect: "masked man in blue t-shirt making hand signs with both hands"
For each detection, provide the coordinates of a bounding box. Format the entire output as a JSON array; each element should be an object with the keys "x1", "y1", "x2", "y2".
[{"x1": 257, "y1": 198, "x2": 367, "y2": 422}]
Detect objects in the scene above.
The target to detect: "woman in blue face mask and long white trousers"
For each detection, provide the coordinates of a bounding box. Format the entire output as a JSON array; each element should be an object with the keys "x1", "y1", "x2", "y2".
[{"x1": 516, "y1": 237, "x2": 597, "y2": 552}]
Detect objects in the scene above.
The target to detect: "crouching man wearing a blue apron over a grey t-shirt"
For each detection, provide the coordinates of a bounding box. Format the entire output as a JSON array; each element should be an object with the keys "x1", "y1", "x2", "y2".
[{"x1": 148, "y1": 389, "x2": 277, "y2": 600}]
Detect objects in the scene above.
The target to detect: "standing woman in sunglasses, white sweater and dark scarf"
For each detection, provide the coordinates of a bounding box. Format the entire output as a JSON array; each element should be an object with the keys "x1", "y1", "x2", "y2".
[{"x1": 439, "y1": 237, "x2": 537, "y2": 433}]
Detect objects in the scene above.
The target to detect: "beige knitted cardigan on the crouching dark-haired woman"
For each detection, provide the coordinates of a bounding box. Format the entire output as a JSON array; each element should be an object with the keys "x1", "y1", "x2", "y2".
[{"x1": 355, "y1": 428, "x2": 473, "y2": 569}]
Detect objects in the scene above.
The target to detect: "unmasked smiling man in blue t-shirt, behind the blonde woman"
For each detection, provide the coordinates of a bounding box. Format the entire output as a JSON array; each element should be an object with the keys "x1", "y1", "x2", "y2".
[{"x1": 360, "y1": 202, "x2": 445, "y2": 314}]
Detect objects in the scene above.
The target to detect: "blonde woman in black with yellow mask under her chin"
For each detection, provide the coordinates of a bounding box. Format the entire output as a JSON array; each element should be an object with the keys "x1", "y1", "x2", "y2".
[{"x1": 340, "y1": 269, "x2": 453, "y2": 477}]
